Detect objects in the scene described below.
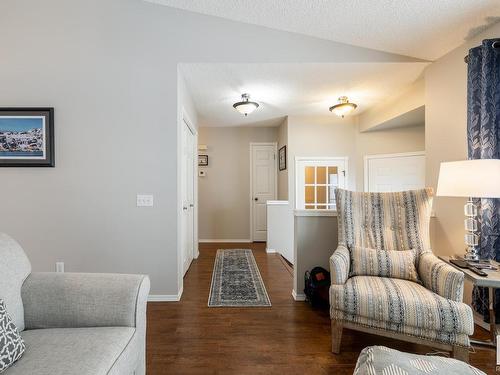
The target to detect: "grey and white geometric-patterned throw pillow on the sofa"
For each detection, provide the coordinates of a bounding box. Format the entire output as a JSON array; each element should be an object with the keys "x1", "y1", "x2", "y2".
[{"x1": 0, "y1": 299, "x2": 26, "y2": 373}]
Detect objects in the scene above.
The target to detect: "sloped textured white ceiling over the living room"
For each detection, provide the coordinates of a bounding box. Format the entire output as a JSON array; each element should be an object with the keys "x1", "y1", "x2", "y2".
[{"x1": 147, "y1": 0, "x2": 500, "y2": 60}]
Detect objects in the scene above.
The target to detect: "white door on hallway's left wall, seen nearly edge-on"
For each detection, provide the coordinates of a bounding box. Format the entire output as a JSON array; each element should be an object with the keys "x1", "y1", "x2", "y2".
[{"x1": 182, "y1": 122, "x2": 196, "y2": 274}]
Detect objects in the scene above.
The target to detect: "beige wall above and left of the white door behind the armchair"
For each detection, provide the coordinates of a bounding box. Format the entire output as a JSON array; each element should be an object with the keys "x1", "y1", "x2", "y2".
[{"x1": 355, "y1": 124, "x2": 425, "y2": 191}]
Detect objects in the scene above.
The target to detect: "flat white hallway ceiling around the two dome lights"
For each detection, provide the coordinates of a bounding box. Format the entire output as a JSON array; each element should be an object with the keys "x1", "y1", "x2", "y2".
[{"x1": 180, "y1": 63, "x2": 428, "y2": 126}]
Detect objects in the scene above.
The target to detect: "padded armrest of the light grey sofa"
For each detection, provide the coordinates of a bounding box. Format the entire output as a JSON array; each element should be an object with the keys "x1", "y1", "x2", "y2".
[{"x1": 21, "y1": 272, "x2": 150, "y2": 329}]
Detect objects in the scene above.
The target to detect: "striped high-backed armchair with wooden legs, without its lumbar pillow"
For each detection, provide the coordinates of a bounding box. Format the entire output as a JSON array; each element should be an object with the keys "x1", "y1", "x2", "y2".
[{"x1": 330, "y1": 189, "x2": 474, "y2": 361}]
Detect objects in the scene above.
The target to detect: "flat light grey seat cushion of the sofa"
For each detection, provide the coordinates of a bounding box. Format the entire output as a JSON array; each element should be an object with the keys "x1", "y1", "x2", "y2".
[{"x1": 2, "y1": 327, "x2": 138, "y2": 375}]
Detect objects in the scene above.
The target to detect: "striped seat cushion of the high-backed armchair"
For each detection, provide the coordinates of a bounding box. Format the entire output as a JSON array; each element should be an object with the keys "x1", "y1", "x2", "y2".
[{"x1": 330, "y1": 276, "x2": 474, "y2": 335}]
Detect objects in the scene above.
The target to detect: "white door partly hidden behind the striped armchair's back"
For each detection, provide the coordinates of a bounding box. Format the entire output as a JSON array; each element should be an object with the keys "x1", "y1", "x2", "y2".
[{"x1": 365, "y1": 152, "x2": 425, "y2": 192}]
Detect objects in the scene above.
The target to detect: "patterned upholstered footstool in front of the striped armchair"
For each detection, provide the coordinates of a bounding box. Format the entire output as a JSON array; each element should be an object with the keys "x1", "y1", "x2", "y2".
[{"x1": 354, "y1": 346, "x2": 486, "y2": 375}]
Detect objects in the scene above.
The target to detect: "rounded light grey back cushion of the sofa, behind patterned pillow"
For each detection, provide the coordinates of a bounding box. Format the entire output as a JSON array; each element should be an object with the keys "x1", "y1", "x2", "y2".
[{"x1": 0, "y1": 233, "x2": 31, "y2": 331}]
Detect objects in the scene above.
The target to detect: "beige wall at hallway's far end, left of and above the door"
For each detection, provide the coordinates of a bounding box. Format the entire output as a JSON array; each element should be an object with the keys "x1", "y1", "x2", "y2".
[{"x1": 198, "y1": 127, "x2": 278, "y2": 240}]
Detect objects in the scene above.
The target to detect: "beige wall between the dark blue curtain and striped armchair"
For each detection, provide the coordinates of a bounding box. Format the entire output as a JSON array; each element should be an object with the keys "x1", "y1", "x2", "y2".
[{"x1": 425, "y1": 24, "x2": 500, "y2": 301}]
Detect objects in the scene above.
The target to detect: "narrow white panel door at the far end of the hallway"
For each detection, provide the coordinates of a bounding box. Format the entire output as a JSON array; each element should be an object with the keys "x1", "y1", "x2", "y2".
[{"x1": 250, "y1": 143, "x2": 277, "y2": 241}]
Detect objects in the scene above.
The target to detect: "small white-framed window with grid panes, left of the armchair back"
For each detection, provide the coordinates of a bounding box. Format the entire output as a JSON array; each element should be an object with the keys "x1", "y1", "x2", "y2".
[{"x1": 295, "y1": 158, "x2": 347, "y2": 210}]
